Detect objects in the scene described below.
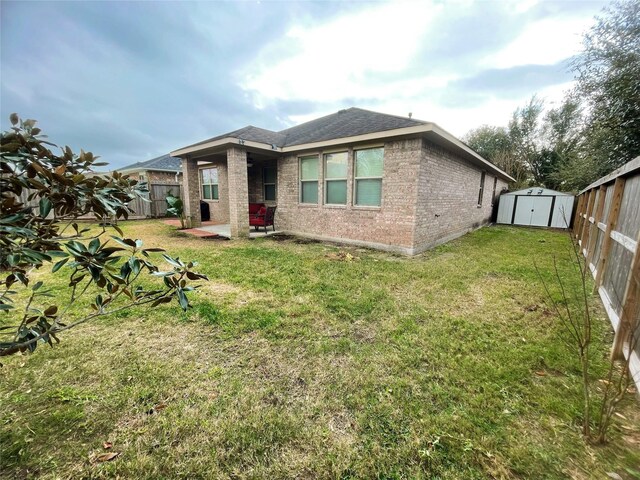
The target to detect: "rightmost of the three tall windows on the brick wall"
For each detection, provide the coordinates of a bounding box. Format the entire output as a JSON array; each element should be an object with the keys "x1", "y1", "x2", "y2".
[{"x1": 354, "y1": 148, "x2": 384, "y2": 207}]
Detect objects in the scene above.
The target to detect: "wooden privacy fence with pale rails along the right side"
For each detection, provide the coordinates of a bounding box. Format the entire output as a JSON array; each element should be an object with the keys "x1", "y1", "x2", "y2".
[{"x1": 573, "y1": 157, "x2": 640, "y2": 387}]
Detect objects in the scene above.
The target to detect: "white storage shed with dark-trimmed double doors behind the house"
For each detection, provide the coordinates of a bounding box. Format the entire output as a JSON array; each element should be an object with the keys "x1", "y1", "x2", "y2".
[{"x1": 498, "y1": 187, "x2": 574, "y2": 228}]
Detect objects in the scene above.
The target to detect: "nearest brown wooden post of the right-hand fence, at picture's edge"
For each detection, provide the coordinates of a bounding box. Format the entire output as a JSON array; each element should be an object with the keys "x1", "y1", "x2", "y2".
[{"x1": 611, "y1": 234, "x2": 640, "y2": 359}]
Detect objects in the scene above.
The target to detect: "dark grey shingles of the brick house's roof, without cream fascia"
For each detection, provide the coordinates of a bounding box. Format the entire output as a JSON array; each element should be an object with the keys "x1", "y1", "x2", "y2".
[{"x1": 182, "y1": 107, "x2": 426, "y2": 147}]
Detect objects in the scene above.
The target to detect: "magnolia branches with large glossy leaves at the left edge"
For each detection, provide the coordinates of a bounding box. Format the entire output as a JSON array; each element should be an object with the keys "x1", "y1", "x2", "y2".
[{"x1": 0, "y1": 114, "x2": 207, "y2": 356}]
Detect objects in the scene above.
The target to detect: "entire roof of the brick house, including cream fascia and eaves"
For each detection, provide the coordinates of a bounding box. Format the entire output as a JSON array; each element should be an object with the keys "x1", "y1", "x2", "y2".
[{"x1": 171, "y1": 107, "x2": 514, "y2": 181}]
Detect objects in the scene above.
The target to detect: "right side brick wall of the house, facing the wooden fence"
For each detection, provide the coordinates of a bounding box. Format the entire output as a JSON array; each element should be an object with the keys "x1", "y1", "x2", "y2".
[{"x1": 415, "y1": 140, "x2": 506, "y2": 252}]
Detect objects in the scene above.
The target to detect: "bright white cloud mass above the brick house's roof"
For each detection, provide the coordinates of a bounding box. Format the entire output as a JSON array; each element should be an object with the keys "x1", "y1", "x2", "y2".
[{"x1": 241, "y1": 0, "x2": 596, "y2": 136}]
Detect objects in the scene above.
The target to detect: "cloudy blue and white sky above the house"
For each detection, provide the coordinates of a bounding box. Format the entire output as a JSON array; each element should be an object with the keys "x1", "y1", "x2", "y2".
[{"x1": 0, "y1": 0, "x2": 608, "y2": 168}]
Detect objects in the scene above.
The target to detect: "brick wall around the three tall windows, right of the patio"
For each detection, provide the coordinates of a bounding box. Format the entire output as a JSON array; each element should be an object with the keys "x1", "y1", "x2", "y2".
[{"x1": 276, "y1": 139, "x2": 422, "y2": 253}]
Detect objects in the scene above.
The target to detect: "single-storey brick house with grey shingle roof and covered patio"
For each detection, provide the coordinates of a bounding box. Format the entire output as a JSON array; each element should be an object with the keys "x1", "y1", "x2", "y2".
[{"x1": 171, "y1": 108, "x2": 513, "y2": 255}]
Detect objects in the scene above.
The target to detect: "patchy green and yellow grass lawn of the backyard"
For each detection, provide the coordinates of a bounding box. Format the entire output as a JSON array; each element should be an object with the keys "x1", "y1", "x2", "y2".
[{"x1": 0, "y1": 221, "x2": 640, "y2": 479}]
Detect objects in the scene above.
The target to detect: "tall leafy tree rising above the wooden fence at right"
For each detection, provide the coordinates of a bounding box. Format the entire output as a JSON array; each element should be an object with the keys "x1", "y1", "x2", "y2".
[{"x1": 572, "y1": 0, "x2": 640, "y2": 174}]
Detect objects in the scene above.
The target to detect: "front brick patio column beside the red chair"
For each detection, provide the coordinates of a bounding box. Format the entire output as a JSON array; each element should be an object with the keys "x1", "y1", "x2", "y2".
[{"x1": 227, "y1": 147, "x2": 249, "y2": 238}]
